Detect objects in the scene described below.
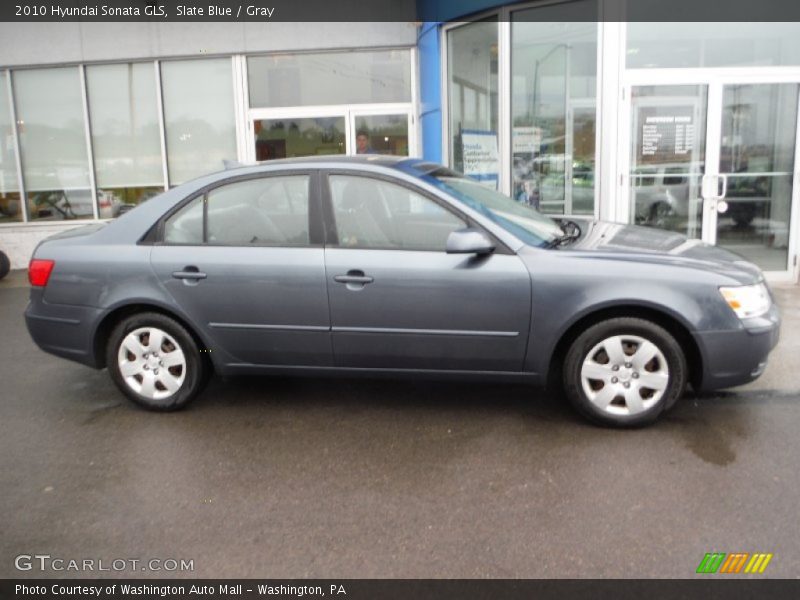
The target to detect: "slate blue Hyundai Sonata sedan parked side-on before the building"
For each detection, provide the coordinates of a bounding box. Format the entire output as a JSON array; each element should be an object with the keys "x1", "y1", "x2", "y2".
[{"x1": 26, "y1": 156, "x2": 779, "y2": 425}]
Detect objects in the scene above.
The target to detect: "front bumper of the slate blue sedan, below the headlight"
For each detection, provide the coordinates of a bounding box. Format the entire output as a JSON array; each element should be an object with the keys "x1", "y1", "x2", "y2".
[{"x1": 695, "y1": 304, "x2": 781, "y2": 390}]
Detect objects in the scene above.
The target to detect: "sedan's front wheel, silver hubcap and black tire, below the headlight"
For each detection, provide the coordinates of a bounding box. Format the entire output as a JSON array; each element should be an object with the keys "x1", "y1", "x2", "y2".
[{"x1": 562, "y1": 317, "x2": 688, "y2": 427}]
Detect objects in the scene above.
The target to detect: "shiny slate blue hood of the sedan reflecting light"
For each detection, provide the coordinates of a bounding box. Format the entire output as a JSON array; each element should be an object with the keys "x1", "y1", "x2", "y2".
[{"x1": 561, "y1": 219, "x2": 763, "y2": 284}]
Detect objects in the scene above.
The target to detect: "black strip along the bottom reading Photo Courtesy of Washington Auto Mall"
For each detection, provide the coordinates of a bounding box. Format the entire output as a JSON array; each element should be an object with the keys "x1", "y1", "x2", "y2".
[{"x1": 0, "y1": 575, "x2": 800, "y2": 600}]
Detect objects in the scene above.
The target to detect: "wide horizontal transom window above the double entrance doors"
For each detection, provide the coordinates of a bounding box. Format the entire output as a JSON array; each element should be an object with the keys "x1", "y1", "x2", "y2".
[{"x1": 626, "y1": 22, "x2": 800, "y2": 69}]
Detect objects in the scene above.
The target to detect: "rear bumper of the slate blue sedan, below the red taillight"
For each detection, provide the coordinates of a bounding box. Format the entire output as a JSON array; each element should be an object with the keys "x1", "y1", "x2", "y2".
[{"x1": 25, "y1": 289, "x2": 102, "y2": 368}]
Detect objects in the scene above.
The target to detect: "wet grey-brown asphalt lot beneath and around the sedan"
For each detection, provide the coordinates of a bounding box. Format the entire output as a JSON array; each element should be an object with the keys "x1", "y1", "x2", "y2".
[{"x1": 0, "y1": 273, "x2": 800, "y2": 578}]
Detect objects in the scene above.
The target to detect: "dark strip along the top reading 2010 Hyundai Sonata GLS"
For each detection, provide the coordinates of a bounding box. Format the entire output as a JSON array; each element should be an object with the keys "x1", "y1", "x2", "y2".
[{"x1": 0, "y1": 0, "x2": 800, "y2": 26}]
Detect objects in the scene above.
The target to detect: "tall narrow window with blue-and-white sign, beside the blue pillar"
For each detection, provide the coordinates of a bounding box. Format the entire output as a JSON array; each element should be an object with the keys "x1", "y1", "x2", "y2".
[{"x1": 447, "y1": 17, "x2": 500, "y2": 189}]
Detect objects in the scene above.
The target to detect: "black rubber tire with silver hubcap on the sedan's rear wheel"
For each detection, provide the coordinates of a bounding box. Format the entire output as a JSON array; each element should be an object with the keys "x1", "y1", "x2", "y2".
[{"x1": 106, "y1": 312, "x2": 210, "y2": 412}]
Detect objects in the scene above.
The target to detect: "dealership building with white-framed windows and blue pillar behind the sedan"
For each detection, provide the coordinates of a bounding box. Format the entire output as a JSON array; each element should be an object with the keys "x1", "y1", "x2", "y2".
[{"x1": 0, "y1": 0, "x2": 800, "y2": 282}]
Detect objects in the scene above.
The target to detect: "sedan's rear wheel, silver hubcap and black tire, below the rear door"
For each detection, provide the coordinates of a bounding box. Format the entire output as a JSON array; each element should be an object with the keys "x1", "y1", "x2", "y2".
[{"x1": 106, "y1": 313, "x2": 207, "y2": 411}]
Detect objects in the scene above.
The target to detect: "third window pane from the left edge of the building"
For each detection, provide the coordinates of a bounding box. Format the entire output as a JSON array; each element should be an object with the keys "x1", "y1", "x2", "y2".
[{"x1": 86, "y1": 63, "x2": 164, "y2": 213}]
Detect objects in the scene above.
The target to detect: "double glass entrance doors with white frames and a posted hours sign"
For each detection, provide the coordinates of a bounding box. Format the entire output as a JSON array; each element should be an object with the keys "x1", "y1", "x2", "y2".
[{"x1": 626, "y1": 78, "x2": 800, "y2": 273}]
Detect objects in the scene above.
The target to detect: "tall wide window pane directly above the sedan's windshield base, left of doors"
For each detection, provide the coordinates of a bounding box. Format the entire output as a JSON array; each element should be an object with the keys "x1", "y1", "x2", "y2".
[{"x1": 511, "y1": 12, "x2": 597, "y2": 215}]
